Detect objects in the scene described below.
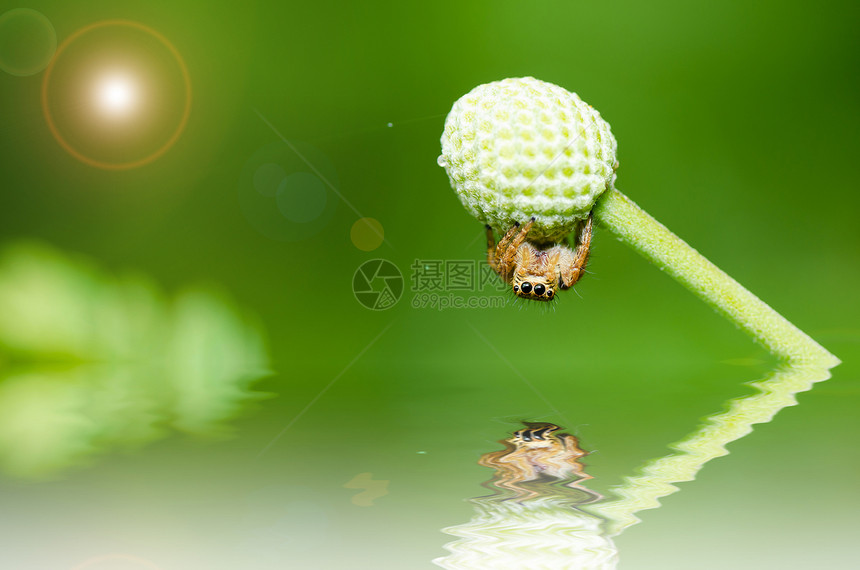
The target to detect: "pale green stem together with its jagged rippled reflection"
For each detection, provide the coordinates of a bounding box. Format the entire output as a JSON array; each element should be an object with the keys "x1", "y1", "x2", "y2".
[{"x1": 588, "y1": 189, "x2": 839, "y2": 535}]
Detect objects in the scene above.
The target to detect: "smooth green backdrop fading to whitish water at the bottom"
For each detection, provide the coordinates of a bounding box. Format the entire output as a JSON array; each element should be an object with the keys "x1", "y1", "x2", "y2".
[{"x1": 0, "y1": 0, "x2": 860, "y2": 570}]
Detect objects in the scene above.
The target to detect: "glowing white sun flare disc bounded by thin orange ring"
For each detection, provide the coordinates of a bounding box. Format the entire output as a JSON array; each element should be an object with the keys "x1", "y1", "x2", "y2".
[{"x1": 41, "y1": 20, "x2": 191, "y2": 170}]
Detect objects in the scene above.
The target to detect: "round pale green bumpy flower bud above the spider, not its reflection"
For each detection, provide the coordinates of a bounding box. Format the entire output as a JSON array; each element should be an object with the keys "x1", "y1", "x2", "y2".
[{"x1": 439, "y1": 77, "x2": 618, "y2": 243}]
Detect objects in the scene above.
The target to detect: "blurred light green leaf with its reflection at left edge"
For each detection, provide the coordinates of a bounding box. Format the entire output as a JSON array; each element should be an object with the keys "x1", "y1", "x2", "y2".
[{"x1": 0, "y1": 244, "x2": 268, "y2": 478}]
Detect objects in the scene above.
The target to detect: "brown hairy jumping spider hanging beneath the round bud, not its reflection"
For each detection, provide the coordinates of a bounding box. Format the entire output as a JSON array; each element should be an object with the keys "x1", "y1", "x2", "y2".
[{"x1": 487, "y1": 214, "x2": 593, "y2": 301}]
